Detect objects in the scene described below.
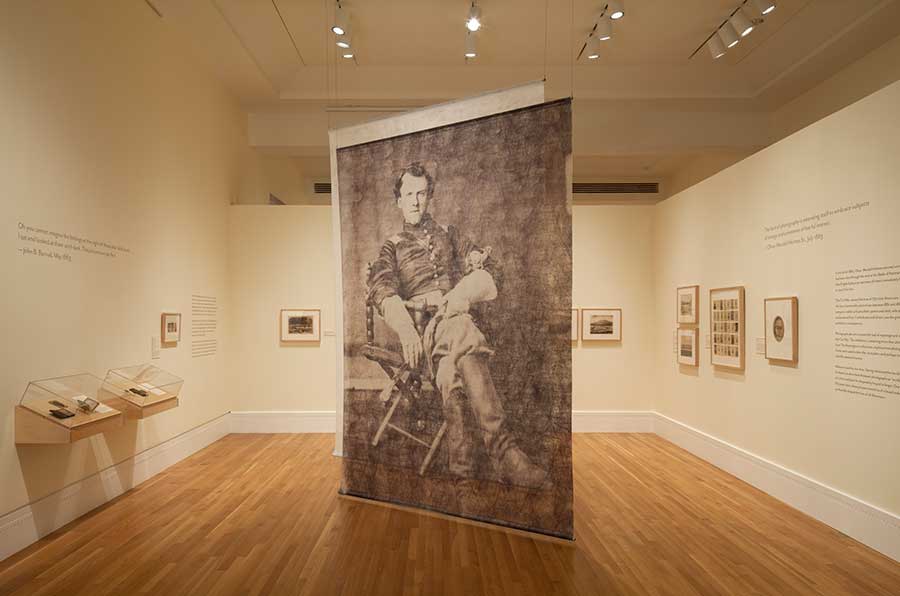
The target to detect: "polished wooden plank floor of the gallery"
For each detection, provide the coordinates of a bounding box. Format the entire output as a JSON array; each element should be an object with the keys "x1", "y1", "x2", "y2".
[{"x1": 0, "y1": 434, "x2": 900, "y2": 596}]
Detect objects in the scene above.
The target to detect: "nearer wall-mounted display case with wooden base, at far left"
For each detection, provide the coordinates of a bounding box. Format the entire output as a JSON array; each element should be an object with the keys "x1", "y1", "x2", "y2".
[{"x1": 16, "y1": 373, "x2": 124, "y2": 443}]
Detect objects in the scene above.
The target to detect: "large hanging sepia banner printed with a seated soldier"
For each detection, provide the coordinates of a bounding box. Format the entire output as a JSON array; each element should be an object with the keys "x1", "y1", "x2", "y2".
[{"x1": 335, "y1": 89, "x2": 573, "y2": 538}]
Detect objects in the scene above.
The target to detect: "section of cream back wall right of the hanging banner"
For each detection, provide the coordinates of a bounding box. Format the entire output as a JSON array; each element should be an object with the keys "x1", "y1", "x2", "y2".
[{"x1": 572, "y1": 205, "x2": 654, "y2": 410}]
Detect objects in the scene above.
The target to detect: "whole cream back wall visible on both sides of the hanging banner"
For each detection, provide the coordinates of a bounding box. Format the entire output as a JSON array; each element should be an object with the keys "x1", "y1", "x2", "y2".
[{"x1": 228, "y1": 205, "x2": 654, "y2": 420}]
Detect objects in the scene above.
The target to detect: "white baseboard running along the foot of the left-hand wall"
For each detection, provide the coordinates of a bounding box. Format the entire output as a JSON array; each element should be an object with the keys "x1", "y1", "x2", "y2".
[{"x1": 0, "y1": 414, "x2": 230, "y2": 561}]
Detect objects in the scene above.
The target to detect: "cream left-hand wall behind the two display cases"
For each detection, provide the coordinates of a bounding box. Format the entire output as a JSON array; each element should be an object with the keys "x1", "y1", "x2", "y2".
[{"x1": 0, "y1": 0, "x2": 247, "y2": 514}]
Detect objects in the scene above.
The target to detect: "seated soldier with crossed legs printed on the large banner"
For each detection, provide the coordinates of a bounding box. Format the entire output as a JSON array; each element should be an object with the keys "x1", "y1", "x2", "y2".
[{"x1": 368, "y1": 163, "x2": 547, "y2": 487}]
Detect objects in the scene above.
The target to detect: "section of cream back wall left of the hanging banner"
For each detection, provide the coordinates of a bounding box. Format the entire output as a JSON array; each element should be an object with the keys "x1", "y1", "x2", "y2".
[{"x1": 228, "y1": 205, "x2": 336, "y2": 411}]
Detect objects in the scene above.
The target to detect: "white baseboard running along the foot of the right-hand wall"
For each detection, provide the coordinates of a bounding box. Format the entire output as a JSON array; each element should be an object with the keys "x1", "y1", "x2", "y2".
[{"x1": 655, "y1": 413, "x2": 900, "y2": 561}]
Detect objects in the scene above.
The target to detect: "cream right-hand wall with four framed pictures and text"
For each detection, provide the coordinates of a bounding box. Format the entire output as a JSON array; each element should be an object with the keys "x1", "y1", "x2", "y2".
[{"x1": 654, "y1": 83, "x2": 900, "y2": 513}]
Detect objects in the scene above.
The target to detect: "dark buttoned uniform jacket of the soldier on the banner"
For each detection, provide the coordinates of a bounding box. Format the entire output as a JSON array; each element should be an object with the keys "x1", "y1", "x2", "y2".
[{"x1": 368, "y1": 213, "x2": 496, "y2": 310}]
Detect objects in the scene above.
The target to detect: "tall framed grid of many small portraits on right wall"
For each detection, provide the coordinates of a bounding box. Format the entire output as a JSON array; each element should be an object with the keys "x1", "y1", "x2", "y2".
[{"x1": 709, "y1": 286, "x2": 744, "y2": 370}]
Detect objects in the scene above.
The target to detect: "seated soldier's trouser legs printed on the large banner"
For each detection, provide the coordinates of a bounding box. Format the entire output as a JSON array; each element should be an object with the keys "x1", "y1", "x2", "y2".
[{"x1": 425, "y1": 314, "x2": 514, "y2": 476}]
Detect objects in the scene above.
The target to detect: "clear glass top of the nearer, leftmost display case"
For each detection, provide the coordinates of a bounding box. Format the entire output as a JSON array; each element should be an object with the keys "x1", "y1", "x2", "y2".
[{"x1": 19, "y1": 373, "x2": 121, "y2": 429}]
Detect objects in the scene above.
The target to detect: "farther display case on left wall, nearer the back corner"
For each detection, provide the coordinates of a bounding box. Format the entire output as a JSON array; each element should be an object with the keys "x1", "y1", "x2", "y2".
[{"x1": 105, "y1": 364, "x2": 184, "y2": 418}]
